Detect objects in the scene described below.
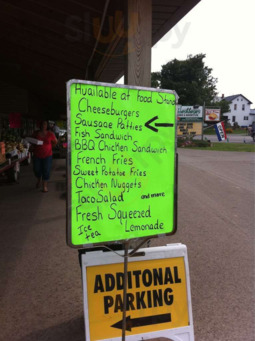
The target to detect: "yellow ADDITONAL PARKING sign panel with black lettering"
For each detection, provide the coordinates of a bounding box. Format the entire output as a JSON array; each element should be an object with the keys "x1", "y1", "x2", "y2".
[{"x1": 83, "y1": 244, "x2": 193, "y2": 341}]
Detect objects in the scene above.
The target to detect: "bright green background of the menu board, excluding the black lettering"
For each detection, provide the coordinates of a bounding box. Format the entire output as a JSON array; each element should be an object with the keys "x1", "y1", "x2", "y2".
[{"x1": 68, "y1": 83, "x2": 176, "y2": 246}]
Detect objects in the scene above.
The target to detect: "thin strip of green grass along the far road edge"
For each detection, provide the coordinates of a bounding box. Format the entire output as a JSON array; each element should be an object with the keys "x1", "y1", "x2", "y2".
[{"x1": 185, "y1": 142, "x2": 255, "y2": 153}]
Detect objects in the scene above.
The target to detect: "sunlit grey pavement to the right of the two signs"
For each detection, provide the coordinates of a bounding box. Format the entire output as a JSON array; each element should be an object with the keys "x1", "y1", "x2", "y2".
[{"x1": 153, "y1": 150, "x2": 255, "y2": 341}]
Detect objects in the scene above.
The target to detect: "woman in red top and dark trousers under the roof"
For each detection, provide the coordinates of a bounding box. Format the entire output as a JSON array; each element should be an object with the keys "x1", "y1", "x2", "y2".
[{"x1": 33, "y1": 121, "x2": 57, "y2": 193}]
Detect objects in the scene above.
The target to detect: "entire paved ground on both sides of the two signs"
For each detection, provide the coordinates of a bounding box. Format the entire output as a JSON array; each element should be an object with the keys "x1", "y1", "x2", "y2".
[{"x1": 0, "y1": 150, "x2": 255, "y2": 341}]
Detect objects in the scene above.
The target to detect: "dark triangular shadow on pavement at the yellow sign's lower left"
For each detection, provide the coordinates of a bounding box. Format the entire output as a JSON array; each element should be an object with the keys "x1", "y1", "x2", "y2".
[{"x1": 19, "y1": 316, "x2": 85, "y2": 341}]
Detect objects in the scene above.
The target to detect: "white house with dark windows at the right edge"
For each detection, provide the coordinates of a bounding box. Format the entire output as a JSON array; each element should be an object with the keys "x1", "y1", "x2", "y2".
[{"x1": 222, "y1": 94, "x2": 255, "y2": 127}]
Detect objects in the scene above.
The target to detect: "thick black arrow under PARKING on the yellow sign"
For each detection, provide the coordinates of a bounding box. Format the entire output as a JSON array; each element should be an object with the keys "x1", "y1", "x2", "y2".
[{"x1": 111, "y1": 314, "x2": 171, "y2": 332}]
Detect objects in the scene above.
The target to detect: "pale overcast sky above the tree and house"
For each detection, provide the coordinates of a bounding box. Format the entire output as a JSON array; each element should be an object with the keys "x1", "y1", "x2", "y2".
[{"x1": 152, "y1": 0, "x2": 255, "y2": 108}]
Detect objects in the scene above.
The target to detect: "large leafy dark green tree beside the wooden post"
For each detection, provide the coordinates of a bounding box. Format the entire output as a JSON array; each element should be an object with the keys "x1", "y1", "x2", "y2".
[{"x1": 151, "y1": 54, "x2": 217, "y2": 105}]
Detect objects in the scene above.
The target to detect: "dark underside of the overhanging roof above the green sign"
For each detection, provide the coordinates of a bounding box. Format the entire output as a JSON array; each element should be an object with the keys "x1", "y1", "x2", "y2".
[{"x1": 0, "y1": 0, "x2": 200, "y2": 102}]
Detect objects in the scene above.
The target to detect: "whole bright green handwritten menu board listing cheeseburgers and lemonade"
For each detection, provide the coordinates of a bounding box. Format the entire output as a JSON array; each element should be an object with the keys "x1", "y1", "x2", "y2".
[{"x1": 67, "y1": 80, "x2": 177, "y2": 248}]
